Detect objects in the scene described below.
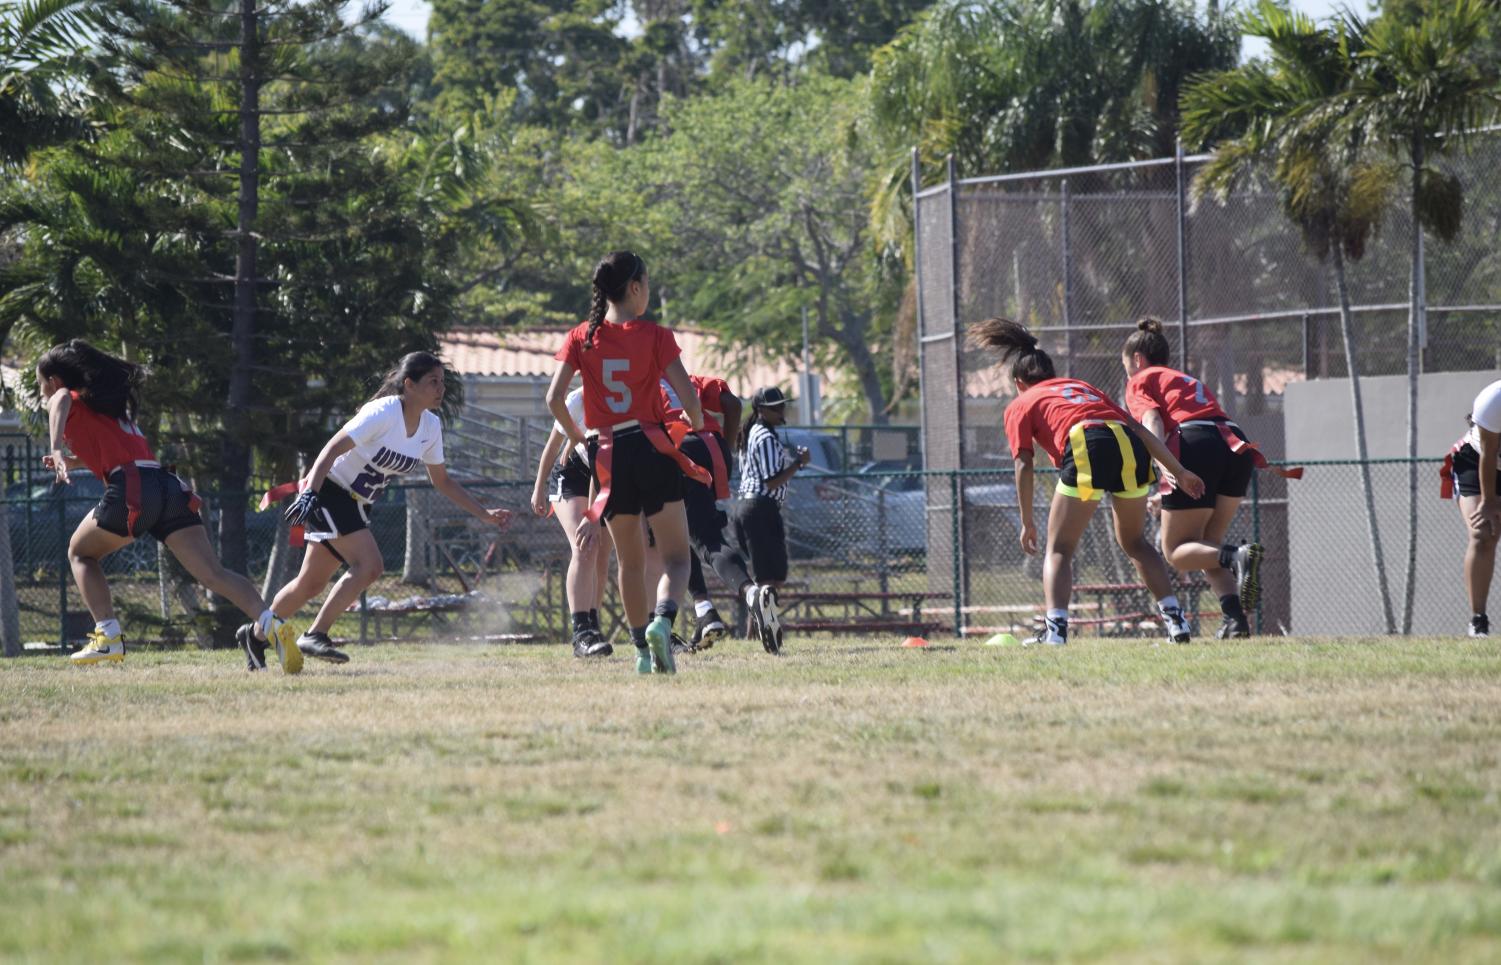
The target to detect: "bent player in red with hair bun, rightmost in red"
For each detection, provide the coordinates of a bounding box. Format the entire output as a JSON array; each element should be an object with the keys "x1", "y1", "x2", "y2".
[{"x1": 1121, "y1": 318, "x2": 1265, "y2": 639}]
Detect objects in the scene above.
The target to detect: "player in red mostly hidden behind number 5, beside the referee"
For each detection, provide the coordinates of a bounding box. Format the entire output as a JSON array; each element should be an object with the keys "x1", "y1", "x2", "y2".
[{"x1": 662, "y1": 375, "x2": 776, "y2": 650}]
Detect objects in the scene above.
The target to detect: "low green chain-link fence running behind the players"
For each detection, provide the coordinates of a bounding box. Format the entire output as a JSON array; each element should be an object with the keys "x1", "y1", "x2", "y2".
[{"x1": 0, "y1": 459, "x2": 1468, "y2": 651}]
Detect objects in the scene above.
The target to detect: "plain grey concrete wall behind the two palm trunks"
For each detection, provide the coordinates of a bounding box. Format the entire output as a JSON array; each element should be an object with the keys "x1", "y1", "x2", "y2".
[{"x1": 1283, "y1": 371, "x2": 1501, "y2": 635}]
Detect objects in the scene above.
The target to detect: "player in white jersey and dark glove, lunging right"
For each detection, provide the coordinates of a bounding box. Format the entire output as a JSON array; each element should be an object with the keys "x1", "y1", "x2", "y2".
[{"x1": 272, "y1": 351, "x2": 510, "y2": 663}]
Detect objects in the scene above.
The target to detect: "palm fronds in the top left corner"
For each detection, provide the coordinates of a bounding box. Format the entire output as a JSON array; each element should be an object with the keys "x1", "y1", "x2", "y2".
[{"x1": 0, "y1": 0, "x2": 104, "y2": 164}]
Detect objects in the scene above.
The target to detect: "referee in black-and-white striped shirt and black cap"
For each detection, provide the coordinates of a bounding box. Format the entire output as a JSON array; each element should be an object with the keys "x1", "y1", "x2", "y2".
[{"x1": 729, "y1": 386, "x2": 809, "y2": 587}]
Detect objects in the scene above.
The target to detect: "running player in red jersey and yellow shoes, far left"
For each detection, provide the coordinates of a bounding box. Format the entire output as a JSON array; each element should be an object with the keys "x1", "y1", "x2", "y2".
[{"x1": 36, "y1": 339, "x2": 302, "y2": 674}]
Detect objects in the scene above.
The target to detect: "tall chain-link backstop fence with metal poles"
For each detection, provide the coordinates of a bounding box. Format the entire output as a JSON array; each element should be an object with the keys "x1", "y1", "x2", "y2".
[{"x1": 913, "y1": 134, "x2": 1501, "y2": 633}]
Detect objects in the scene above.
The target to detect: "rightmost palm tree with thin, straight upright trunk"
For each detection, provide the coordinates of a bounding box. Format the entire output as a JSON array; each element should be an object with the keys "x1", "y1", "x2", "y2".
[{"x1": 1343, "y1": 0, "x2": 1501, "y2": 633}]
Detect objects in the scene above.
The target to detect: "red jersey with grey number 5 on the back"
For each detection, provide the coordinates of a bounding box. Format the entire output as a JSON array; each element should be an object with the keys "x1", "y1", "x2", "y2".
[{"x1": 554, "y1": 318, "x2": 683, "y2": 429}]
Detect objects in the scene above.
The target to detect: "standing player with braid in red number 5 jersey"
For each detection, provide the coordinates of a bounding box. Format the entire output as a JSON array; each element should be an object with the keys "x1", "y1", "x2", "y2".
[{"x1": 548, "y1": 251, "x2": 708, "y2": 674}]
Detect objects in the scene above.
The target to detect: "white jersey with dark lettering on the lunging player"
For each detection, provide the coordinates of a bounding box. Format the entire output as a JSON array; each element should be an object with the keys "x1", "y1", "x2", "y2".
[{"x1": 329, "y1": 395, "x2": 443, "y2": 503}]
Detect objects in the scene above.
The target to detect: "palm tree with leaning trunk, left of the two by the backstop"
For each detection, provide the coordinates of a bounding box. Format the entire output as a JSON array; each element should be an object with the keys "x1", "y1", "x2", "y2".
[{"x1": 1183, "y1": 0, "x2": 1396, "y2": 633}]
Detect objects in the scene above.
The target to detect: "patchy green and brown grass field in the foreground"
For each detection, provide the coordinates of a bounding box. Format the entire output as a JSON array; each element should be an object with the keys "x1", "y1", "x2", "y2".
[{"x1": 0, "y1": 639, "x2": 1501, "y2": 962}]
